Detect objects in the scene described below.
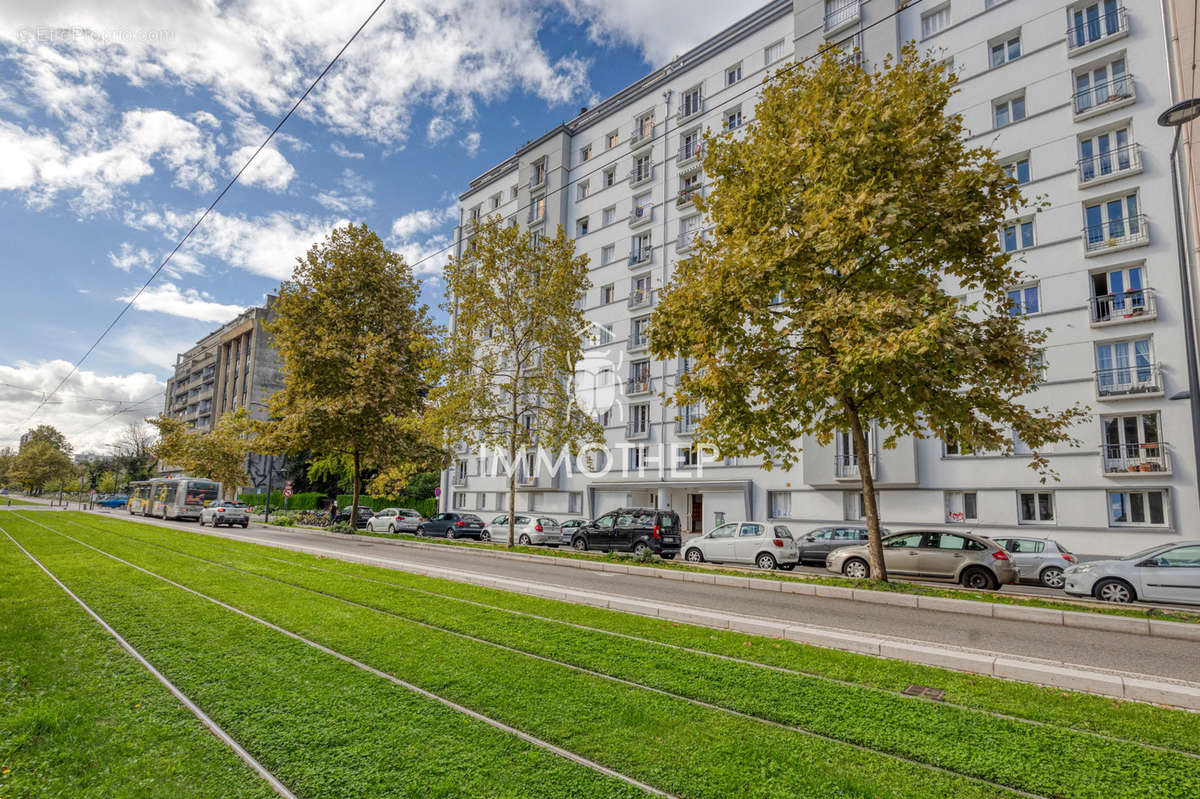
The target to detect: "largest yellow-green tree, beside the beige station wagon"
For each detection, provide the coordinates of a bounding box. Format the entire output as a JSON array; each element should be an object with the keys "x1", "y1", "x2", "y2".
[{"x1": 650, "y1": 44, "x2": 1085, "y2": 579}]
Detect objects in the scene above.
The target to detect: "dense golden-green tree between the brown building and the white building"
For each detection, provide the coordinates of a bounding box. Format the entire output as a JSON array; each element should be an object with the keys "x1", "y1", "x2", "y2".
[{"x1": 263, "y1": 224, "x2": 440, "y2": 524}]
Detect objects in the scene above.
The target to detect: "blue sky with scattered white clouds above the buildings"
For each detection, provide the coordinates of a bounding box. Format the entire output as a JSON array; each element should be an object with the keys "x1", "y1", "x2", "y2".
[{"x1": 0, "y1": 0, "x2": 757, "y2": 452}]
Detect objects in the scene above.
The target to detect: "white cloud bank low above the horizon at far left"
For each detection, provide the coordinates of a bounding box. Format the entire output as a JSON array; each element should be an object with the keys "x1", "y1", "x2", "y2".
[{"x1": 0, "y1": 360, "x2": 166, "y2": 452}]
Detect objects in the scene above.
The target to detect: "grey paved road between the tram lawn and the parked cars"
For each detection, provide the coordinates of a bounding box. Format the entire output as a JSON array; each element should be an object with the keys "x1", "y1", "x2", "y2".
[{"x1": 77, "y1": 513, "x2": 1200, "y2": 681}]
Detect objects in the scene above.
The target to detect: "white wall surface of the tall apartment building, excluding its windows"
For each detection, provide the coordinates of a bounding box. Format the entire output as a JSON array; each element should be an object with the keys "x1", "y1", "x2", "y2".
[{"x1": 445, "y1": 0, "x2": 1200, "y2": 554}]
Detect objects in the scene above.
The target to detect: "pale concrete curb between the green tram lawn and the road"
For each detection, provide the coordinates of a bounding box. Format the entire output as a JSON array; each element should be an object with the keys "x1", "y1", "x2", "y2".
[{"x1": 204, "y1": 531, "x2": 1200, "y2": 710}]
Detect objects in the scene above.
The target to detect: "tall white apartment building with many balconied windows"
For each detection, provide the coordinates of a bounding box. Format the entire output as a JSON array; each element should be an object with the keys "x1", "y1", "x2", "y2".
[{"x1": 443, "y1": 0, "x2": 1200, "y2": 554}]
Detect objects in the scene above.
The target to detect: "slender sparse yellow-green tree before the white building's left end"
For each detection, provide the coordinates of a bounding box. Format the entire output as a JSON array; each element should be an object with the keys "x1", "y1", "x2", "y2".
[{"x1": 430, "y1": 218, "x2": 604, "y2": 546}]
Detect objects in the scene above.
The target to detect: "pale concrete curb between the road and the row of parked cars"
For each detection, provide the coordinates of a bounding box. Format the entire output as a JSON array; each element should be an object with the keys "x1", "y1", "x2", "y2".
[{"x1": 319, "y1": 528, "x2": 1200, "y2": 641}]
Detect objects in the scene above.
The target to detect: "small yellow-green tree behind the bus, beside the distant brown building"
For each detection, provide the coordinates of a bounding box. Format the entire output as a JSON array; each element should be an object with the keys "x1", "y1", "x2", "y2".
[{"x1": 146, "y1": 408, "x2": 256, "y2": 497}]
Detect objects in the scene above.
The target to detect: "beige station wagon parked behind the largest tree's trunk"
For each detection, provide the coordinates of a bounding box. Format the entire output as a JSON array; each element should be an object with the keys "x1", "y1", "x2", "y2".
[{"x1": 826, "y1": 531, "x2": 1018, "y2": 590}]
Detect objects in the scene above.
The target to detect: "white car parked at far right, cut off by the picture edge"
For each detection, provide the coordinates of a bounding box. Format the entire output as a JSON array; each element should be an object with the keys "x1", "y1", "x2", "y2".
[{"x1": 1063, "y1": 540, "x2": 1200, "y2": 605}]
